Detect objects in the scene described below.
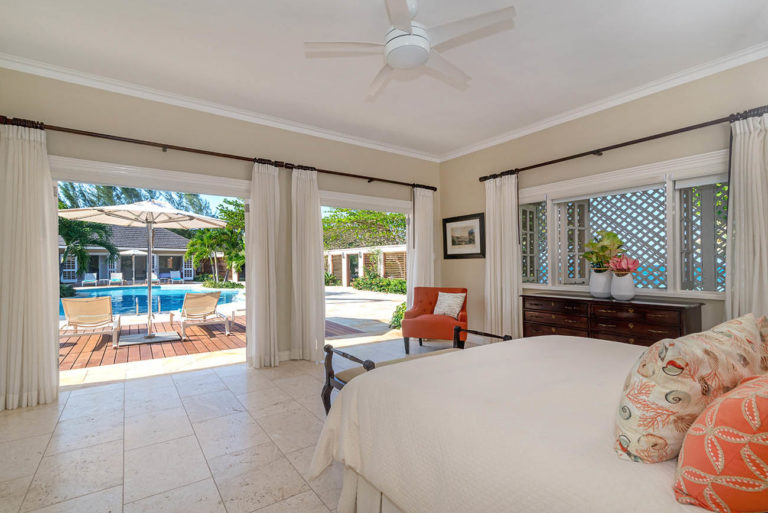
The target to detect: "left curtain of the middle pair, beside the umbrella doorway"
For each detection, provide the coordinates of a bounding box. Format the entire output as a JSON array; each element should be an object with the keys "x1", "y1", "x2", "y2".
[{"x1": 245, "y1": 163, "x2": 280, "y2": 368}]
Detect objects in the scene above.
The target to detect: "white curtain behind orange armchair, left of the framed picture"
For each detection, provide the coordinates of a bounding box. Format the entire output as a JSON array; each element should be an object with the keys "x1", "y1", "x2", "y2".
[{"x1": 406, "y1": 187, "x2": 435, "y2": 308}]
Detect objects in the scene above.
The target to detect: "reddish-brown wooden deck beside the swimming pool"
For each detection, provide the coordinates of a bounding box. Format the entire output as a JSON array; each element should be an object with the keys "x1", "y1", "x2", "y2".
[{"x1": 59, "y1": 316, "x2": 360, "y2": 370}]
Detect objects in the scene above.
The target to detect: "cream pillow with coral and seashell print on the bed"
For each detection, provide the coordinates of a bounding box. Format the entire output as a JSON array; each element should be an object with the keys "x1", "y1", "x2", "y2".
[{"x1": 616, "y1": 314, "x2": 768, "y2": 463}]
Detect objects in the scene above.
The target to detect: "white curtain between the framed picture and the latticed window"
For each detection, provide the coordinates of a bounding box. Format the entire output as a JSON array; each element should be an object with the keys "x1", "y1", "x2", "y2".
[{"x1": 485, "y1": 175, "x2": 521, "y2": 338}]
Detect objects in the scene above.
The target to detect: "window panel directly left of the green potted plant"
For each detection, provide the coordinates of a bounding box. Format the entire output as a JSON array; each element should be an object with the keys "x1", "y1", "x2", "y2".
[{"x1": 557, "y1": 200, "x2": 590, "y2": 284}]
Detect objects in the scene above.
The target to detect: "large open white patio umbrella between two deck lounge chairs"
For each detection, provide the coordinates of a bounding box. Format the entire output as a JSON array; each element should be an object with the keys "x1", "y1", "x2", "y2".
[{"x1": 59, "y1": 200, "x2": 227, "y2": 345}]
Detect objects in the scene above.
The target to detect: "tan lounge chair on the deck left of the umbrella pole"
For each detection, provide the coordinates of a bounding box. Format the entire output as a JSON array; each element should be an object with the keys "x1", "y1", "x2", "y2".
[{"x1": 59, "y1": 296, "x2": 120, "y2": 347}]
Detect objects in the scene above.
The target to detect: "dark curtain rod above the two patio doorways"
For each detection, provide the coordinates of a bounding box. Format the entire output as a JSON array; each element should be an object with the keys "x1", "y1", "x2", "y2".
[{"x1": 0, "y1": 116, "x2": 437, "y2": 191}]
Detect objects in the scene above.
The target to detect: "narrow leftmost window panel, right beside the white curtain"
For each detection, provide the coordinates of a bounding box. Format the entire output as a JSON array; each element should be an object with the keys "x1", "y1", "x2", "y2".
[{"x1": 520, "y1": 201, "x2": 548, "y2": 283}]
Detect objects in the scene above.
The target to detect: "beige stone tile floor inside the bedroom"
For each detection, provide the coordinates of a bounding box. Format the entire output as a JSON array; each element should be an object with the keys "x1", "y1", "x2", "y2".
[{"x1": 0, "y1": 340, "x2": 446, "y2": 513}]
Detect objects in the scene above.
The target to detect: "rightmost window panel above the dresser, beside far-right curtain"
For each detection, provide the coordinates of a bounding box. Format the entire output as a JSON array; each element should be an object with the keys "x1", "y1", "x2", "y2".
[{"x1": 678, "y1": 183, "x2": 728, "y2": 292}]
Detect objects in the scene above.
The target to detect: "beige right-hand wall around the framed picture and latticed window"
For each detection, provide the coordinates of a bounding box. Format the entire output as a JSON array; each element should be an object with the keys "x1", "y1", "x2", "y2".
[{"x1": 440, "y1": 59, "x2": 768, "y2": 328}]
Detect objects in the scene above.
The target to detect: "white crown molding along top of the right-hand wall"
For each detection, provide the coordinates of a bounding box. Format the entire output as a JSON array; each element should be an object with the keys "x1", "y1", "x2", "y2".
[{"x1": 440, "y1": 41, "x2": 768, "y2": 162}]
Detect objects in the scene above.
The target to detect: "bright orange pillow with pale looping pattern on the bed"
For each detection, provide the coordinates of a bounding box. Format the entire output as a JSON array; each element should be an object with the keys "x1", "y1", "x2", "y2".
[{"x1": 675, "y1": 376, "x2": 768, "y2": 513}]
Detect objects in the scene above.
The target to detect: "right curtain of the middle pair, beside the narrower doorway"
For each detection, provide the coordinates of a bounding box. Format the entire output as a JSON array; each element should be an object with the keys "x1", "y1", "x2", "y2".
[{"x1": 291, "y1": 169, "x2": 325, "y2": 361}]
